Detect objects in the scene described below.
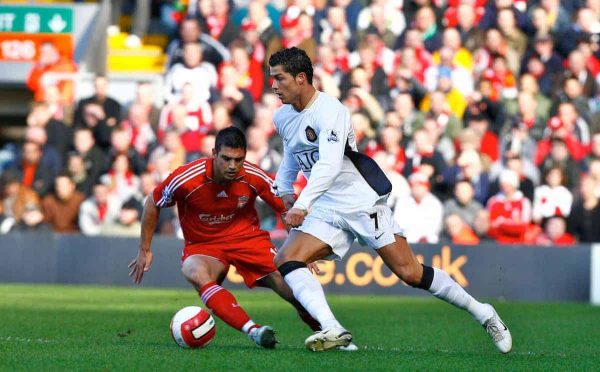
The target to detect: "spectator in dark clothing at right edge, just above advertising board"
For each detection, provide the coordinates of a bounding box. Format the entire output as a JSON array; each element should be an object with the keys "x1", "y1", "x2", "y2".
[{"x1": 568, "y1": 175, "x2": 600, "y2": 243}]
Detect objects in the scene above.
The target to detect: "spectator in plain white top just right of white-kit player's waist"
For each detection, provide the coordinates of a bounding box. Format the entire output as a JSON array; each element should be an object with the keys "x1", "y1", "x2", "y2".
[{"x1": 394, "y1": 172, "x2": 444, "y2": 243}]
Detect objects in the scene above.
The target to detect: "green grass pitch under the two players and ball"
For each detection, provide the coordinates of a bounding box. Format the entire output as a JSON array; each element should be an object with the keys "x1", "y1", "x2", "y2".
[{"x1": 0, "y1": 285, "x2": 600, "y2": 371}]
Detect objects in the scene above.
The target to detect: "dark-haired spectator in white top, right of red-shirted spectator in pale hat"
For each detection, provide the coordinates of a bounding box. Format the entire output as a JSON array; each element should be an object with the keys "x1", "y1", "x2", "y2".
[{"x1": 533, "y1": 165, "x2": 573, "y2": 224}]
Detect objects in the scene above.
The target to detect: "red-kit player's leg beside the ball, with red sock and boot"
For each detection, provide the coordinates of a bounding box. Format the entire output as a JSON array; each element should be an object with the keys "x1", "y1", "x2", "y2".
[{"x1": 181, "y1": 254, "x2": 277, "y2": 348}]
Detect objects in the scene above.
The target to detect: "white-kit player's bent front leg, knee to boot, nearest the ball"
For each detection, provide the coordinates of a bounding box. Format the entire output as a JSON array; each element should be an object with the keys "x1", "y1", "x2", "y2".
[{"x1": 275, "y1": 230, "x2": 352, "y2": 351}]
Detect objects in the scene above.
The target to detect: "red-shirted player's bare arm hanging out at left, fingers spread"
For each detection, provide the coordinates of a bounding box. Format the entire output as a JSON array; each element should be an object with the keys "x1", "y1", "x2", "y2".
[{"x1": 128, "y1": 195, "x2": 160, "y2": 284}]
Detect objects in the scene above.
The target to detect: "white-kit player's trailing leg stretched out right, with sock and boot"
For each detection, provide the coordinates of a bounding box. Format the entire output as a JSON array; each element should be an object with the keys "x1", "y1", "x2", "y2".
[{"x1": 377, "y1": 235, "x2": 512, "y2": 353}]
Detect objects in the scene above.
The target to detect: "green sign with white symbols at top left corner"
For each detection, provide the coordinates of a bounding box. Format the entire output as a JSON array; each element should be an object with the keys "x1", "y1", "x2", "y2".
[{"x1": 0, "y1": 5, "x2": 73, "y2": 34}]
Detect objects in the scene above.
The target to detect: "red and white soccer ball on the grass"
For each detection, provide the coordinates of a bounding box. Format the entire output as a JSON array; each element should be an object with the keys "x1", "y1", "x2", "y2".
[{"x1": 171, "y1": 306, "x2": 216, "y2": 349}]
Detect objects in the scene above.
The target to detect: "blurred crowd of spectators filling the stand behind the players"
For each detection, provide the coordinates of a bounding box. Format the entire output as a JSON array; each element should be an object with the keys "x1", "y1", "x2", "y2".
[{"x1": 0, "y1": 0, "x2": 600, "y2": 245}]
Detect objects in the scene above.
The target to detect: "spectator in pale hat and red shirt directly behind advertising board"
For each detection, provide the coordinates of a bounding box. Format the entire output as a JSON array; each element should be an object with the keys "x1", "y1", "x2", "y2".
[{"x1": 487, "y1": 169, "x2": 531, "y2": 243}]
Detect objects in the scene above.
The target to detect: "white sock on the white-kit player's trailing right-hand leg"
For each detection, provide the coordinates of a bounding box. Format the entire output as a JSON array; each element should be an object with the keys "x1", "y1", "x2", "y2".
[{"x1": 429, "y1": 267, "x2": 493, "y2": 324}]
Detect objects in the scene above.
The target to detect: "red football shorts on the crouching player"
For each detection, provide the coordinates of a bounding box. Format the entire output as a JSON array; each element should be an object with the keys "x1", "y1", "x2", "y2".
[{"x1": 181, "y1": 236, "x2": 277, "y2": 288}]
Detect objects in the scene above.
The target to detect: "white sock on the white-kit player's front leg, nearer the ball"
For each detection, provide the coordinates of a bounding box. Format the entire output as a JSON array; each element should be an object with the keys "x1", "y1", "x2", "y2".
[{"x1": 284, "y1": 267, "x2": 341, "y2": 329}]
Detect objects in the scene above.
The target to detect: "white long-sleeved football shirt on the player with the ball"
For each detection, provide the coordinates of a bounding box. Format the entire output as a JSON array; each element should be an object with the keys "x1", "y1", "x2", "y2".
[{"x1": 273, "y1": 92, "x2": 387, "y2": 211}]
